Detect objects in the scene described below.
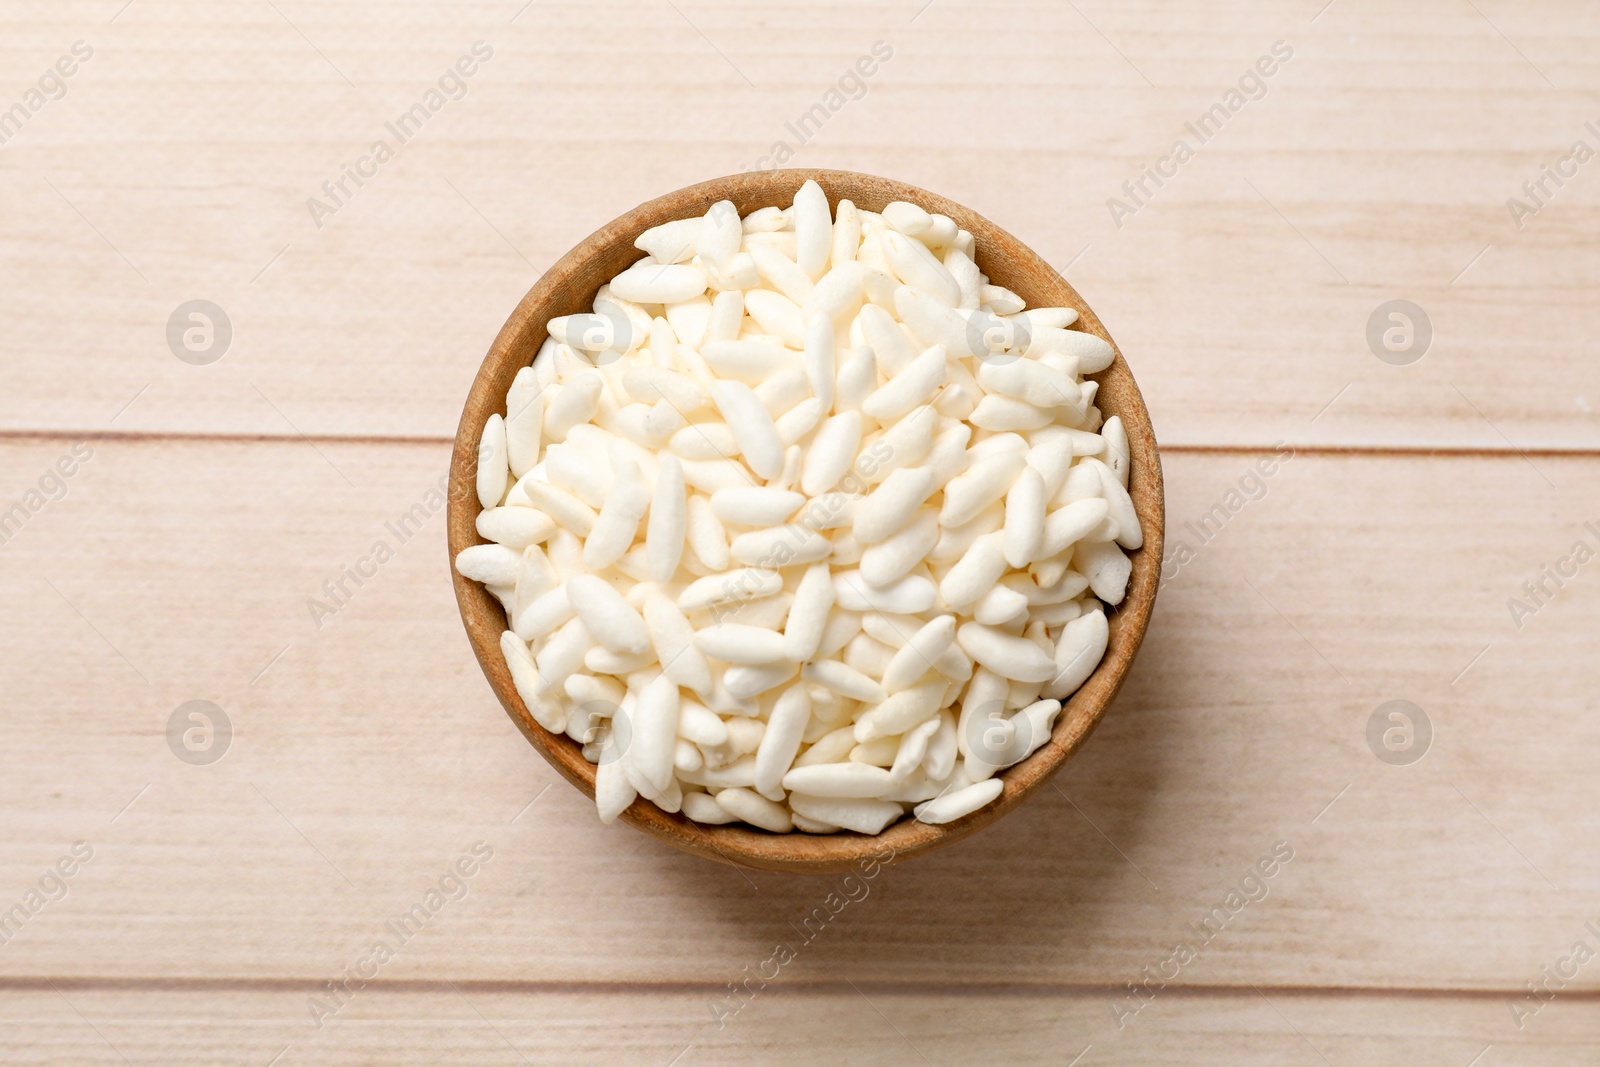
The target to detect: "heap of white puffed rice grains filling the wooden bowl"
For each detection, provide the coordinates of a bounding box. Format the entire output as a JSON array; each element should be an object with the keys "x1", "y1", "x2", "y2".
[{"x1": 456, "y1": 181, "x2": 1142, "y2": 833}]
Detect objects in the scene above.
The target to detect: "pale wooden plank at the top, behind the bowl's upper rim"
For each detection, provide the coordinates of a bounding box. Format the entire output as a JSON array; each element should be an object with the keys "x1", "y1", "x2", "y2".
[{"x1": 0, "y1": 0, "x2": 1600, "y2": 450}]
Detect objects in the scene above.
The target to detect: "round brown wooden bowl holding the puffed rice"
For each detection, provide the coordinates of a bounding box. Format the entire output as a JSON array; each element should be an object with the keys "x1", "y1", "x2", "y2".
[{"x1": 450, "y1": 170, "x2": 1163, "y2": 872}]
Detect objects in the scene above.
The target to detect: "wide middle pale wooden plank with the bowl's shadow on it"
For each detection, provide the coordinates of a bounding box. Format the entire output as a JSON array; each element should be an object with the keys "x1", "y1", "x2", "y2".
[{"x1": 0, "y1": 440, "x2": 1600, "y2": 990}]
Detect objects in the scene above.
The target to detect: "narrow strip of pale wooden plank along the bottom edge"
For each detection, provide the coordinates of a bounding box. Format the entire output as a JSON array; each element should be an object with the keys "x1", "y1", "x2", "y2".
[{"x1": 0, "y1": 985, "x2": 1600, "y2": 1067}]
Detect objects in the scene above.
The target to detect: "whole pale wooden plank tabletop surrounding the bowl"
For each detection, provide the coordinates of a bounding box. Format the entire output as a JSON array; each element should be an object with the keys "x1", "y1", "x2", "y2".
[{"x1": 0, "y1": 0, "x2": 1600, "y2": 1067}]
